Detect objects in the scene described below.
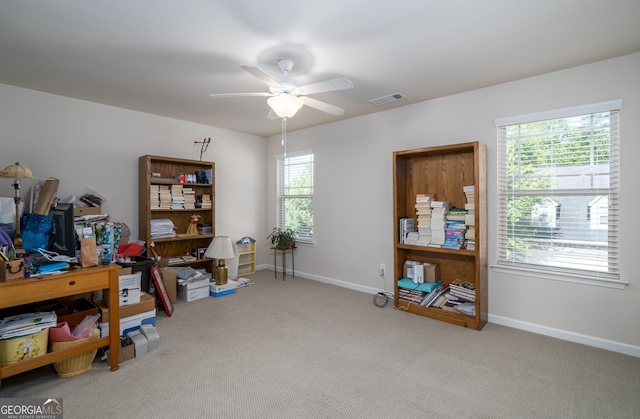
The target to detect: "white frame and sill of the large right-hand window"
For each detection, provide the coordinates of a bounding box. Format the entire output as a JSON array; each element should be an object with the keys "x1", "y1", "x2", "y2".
[{"x1": 491, "y1": 100, "x2": 628, "y2": 289}]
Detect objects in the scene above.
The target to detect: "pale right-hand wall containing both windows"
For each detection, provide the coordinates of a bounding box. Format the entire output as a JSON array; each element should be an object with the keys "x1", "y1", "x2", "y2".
[{"x1": 265, "y1": 50, "x2": 640, "y2": 356}]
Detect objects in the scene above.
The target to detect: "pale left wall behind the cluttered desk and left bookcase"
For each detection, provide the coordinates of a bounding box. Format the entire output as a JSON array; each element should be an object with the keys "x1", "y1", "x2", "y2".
[{"x1": 0, "y1": 84, "x2": 266, "y2": 259}]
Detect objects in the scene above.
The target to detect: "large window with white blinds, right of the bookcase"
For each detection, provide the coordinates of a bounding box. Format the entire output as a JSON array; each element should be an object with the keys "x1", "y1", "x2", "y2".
[{"x1": 496, "y1": 101, "x2": 622, "y2": 282}]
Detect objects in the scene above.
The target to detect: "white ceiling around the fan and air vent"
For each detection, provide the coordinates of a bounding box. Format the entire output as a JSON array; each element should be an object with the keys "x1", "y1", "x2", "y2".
[{"x1": 0, "y1": 0, "x2": 640, "y2": 136}]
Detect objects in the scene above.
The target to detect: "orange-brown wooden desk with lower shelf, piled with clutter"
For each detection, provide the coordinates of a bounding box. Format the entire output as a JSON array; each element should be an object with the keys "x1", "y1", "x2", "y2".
[{"x1": 0, "y1": 264, "x2": 120, "y2": 379}]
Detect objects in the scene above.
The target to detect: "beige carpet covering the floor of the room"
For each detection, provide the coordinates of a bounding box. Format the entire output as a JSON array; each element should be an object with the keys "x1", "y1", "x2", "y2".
[{"x1": 0, "y1": 271, "x2": 640, "y2": 419}]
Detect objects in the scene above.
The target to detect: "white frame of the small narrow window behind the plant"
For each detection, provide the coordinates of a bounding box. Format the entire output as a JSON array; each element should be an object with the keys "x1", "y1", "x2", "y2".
[{"x1": 276, "y1": 150, "x2": 315, "y2": 246}]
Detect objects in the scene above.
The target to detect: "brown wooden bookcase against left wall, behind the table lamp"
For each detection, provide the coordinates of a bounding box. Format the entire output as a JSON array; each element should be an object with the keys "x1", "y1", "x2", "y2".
[{"x1": 138, "y1": 155, "x2": 216, "y2": 272}]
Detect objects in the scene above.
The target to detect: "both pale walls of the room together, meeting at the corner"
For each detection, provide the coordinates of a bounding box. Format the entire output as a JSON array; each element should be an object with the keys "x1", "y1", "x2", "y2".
[{"x1": 0, "y1": 54, "x2": 640, "y2": 356}]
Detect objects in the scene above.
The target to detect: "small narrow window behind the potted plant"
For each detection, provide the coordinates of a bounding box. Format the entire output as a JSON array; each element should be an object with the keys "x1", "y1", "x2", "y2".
[{"x1": 277, "y1": 150, "x2": 313, "y2": 244}]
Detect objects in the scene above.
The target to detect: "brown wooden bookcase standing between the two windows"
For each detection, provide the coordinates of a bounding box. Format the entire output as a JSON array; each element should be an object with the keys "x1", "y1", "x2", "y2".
[{"x1": 393, "y1": 142, "x2": 487, "y2": 330}]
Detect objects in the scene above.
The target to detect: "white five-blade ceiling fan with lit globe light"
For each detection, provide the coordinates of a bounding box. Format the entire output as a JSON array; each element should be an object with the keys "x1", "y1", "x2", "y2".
[{"x1": 209, "y1": 60, "x2": 353, "y2": 119}]
